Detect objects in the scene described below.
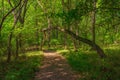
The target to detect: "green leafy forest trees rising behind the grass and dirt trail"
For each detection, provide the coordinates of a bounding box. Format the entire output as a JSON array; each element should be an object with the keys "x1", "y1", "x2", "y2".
[{"x1": 0, "y1": 0, "x2": 120, "y2": 61}]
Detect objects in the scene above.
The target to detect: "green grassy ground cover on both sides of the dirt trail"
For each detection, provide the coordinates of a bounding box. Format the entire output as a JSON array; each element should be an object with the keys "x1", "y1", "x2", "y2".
[{"x1": 0, "y1": 45, "x2": 120, "y2": 80}]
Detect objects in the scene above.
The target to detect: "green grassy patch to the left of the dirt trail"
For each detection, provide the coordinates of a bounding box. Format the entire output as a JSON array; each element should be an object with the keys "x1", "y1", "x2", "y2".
[{"x1": 0, "y1": 51, "x2": 42, "y2": 80}]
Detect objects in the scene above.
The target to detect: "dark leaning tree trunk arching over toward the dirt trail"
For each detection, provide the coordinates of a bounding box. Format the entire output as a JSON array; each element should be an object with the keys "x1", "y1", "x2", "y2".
[{"x1": 43, "y1": 27, "x2": 106, "y2": 58}]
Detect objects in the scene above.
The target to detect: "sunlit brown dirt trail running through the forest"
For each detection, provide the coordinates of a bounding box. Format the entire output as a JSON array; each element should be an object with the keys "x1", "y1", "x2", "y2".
[{"x1": 34, "y1": 51, "x2": 80, "y2": 80}]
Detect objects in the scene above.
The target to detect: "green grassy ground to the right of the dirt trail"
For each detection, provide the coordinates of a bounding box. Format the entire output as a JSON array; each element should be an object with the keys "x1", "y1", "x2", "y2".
[{"x1": 59, "y1": 46, "x2": 120, "y2": 80}]
